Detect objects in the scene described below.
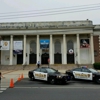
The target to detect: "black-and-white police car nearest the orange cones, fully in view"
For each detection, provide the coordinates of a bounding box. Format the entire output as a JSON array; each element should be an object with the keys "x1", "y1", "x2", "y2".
[{"x1": 28, "y1": 67, "x2": 70, "y2": 84}]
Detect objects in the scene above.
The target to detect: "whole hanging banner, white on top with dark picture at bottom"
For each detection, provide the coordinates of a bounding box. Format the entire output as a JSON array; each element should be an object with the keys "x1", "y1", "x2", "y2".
[{"x1": 13, "y1": 41, "x2": 23, "y2": 54}]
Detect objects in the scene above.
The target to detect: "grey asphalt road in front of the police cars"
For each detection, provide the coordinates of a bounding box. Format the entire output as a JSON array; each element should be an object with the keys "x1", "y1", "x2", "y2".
[{"x1": 0, "y1": 78, "x2": 100, "y2": 100}]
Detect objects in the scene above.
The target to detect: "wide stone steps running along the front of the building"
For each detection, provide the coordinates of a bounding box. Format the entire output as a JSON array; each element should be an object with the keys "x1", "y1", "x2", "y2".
[{"x1": 0, "y1": 64, "x2": 93, "y2": 70}]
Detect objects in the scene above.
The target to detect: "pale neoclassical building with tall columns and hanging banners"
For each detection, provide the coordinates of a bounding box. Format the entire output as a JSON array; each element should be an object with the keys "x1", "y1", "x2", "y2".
[{"x1": 0, "y1": 20, "x2": 100, "y2": 65}]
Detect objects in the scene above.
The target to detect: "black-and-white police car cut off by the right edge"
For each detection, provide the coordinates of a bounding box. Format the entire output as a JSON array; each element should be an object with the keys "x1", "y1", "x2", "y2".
[{"x1": 66, "y1": 67, "x2": 100, "y2": 84}]
